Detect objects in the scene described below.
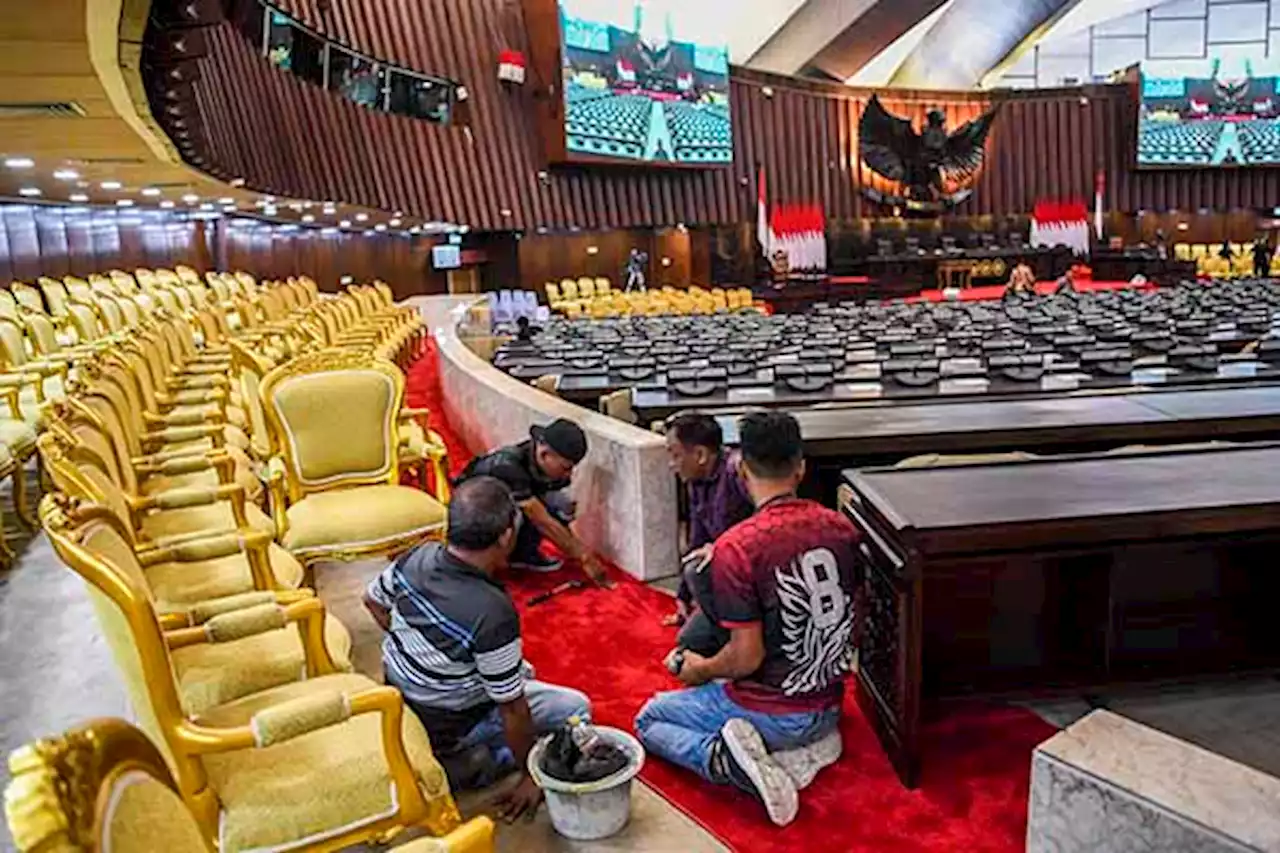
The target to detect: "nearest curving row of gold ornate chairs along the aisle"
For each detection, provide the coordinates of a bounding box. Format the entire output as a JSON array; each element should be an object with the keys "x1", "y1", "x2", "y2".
[{"x1": 6, "y1": 270, "x2": 493, "y2": 853}]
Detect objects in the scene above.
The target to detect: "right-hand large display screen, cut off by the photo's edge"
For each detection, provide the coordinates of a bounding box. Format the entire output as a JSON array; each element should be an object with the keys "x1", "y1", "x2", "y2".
[{"x1": 1138, "y1": 60, "x2": 1280, "y2": 168}]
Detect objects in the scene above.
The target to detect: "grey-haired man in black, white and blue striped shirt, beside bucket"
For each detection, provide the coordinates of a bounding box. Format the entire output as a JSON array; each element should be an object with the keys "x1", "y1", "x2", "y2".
[{"x1": 365, "y1": 476, "x2": 591, "y2": 818}]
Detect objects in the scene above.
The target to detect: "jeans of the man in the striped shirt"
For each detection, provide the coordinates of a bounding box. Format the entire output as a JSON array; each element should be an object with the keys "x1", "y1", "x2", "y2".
[{"x1": 436, "y1": 680, "x2": 591, "y2": 788}]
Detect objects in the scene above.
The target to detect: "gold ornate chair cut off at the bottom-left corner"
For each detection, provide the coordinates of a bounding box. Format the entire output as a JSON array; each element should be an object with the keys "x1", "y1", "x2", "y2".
[{"x1": 5, "y1": 719, "x2": 494, "y2": 853}]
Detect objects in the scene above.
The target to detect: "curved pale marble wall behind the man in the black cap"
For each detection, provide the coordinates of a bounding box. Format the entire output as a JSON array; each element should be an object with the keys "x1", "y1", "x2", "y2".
[{"x1": 435, "y1": 309, "x2": 678, "y2": 580}]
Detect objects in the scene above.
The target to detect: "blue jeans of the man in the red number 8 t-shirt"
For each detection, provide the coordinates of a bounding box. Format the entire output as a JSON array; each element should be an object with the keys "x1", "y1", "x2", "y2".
[{"x1": 636, "y1": 681, "x2": 840, "y2": 783}]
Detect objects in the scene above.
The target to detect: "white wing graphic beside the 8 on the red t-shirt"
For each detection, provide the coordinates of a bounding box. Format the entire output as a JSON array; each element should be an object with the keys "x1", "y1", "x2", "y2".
[{"x1": 774, "y1": 565, "x2": 854, "y2": 695}]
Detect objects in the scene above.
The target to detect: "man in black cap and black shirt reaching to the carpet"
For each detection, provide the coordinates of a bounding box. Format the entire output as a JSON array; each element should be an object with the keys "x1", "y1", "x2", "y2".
[{"x1": 458, "y1": 418, "x2": 604, "y2": 583}]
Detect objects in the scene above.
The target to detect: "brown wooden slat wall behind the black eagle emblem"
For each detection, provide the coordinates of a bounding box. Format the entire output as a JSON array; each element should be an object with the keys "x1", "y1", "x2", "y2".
[{"x1": 170, "y1": 0, "x2": 1280, "y2": 231}]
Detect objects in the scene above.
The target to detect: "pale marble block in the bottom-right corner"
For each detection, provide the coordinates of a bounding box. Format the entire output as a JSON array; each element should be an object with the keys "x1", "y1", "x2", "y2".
[{"x1": 1027, "y1": 711, "x2": 1280, "y2": 853}]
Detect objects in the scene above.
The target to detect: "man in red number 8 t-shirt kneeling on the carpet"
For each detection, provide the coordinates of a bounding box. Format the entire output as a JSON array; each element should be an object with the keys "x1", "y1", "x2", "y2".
[{"x1": 636, "y1": 411, "x2": 861, "y2": 826}]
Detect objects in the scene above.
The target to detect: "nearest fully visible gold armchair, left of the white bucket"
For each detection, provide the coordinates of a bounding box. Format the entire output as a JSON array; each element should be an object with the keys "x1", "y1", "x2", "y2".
[{"x1": 41, "y1": 496, "x2": 471, "y2": 853}]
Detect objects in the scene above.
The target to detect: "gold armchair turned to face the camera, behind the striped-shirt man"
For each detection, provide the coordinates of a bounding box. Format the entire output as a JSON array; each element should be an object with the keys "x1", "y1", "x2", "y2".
[{"x1": 260, "y1": 350, "x2": 444, "y2": 564}]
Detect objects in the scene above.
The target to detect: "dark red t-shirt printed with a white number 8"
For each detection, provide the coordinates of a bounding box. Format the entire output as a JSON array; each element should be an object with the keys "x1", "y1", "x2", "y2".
[{"x1": 708, "y1": 497, "x2": 861, "y2": 713}]
